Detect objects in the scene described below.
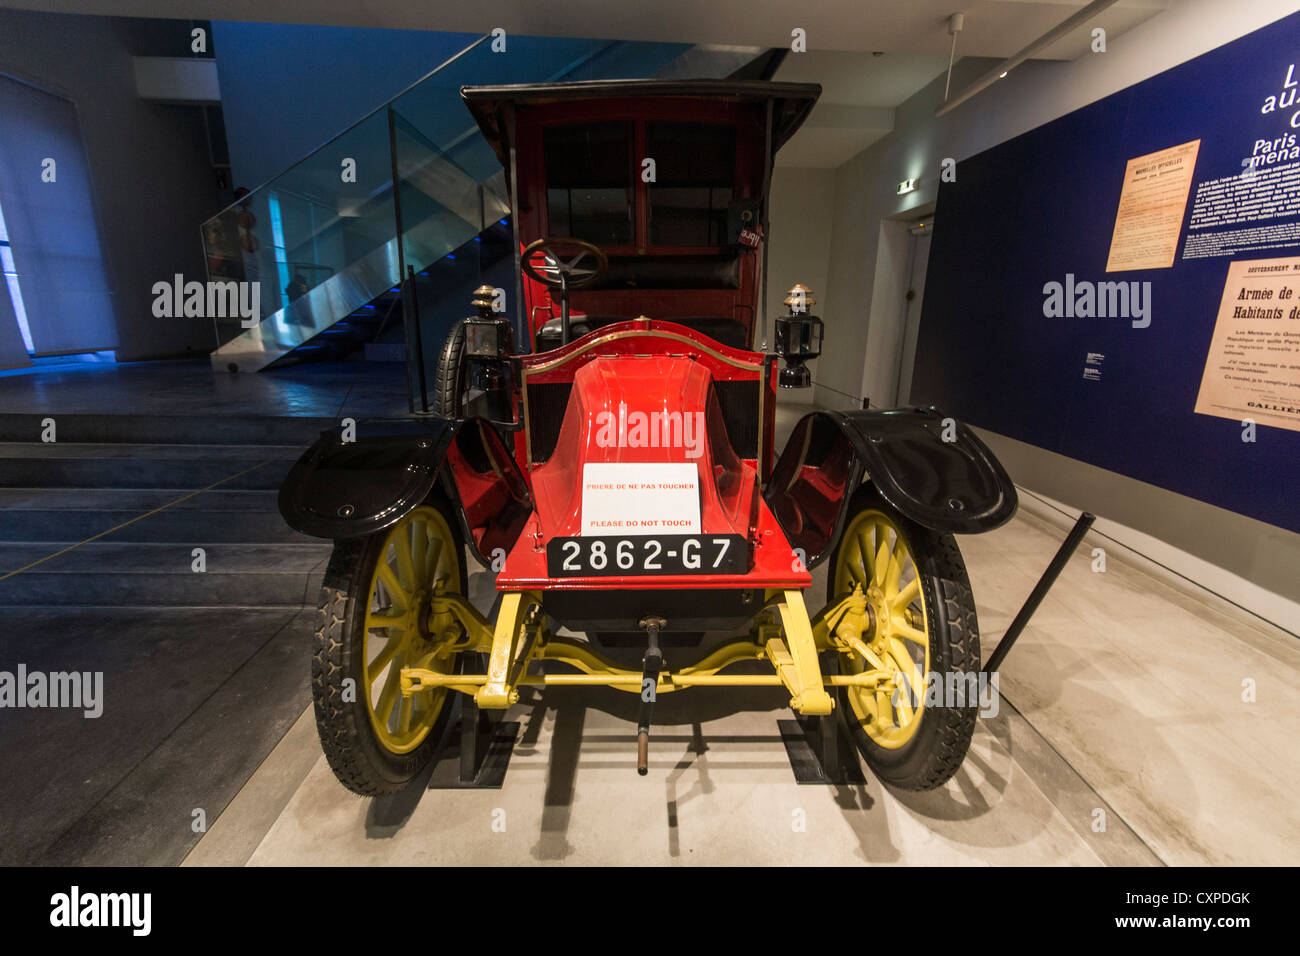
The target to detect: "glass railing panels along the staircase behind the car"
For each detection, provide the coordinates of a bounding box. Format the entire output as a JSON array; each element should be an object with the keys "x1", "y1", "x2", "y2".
[{"x1": 202, "y1": 29, "x2": 733, "y2": 408}]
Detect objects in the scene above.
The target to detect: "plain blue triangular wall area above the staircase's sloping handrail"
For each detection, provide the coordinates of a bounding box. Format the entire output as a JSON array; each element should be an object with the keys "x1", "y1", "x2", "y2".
[{"x1": 212, "y1": 21, "x2": 477, "y2": 189}]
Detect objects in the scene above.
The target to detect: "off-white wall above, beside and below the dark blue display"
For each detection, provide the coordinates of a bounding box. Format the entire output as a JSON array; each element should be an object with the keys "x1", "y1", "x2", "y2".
[{"x1": 815, "y1": 0, "x2": 1300, "y2": 613}]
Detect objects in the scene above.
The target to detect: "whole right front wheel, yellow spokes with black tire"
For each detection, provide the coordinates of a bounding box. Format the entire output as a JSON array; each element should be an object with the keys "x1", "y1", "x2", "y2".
[{"x1": 827, "y1": 486, "x2": 980, "y2": 790}]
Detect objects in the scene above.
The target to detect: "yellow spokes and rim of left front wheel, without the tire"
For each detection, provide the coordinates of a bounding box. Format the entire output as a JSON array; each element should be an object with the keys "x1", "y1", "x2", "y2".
[{"x1": 361, "y1": 505, "x2": 460, "y2": 753}]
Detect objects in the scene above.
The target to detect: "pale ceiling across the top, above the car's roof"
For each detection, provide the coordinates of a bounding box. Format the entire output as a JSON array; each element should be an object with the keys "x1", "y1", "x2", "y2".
[{"x1": 0, "y1": 0, "x2": 1179, "y2": 168}]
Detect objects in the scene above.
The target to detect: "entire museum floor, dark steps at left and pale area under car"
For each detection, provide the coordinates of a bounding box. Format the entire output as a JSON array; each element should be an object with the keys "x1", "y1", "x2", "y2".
[{"x1": 0, "y1": 363, "x2": 1300, "y2": 865}]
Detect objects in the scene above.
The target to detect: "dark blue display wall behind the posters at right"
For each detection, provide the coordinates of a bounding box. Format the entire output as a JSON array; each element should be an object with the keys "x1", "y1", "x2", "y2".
[{"x1": 911, "y1": 14, "x2": 1300, "y2": 531}]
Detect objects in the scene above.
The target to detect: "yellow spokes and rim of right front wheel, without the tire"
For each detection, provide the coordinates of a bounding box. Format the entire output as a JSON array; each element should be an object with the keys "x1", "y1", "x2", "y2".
[{"x1": 832, "y1": 509, "x2": 930, "y2": 750}]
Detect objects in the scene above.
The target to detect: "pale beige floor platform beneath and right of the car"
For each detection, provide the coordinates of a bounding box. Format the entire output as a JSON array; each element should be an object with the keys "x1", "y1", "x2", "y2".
[{"x1": 186, "y1": 470, "x2": 1300, "y2": 866}]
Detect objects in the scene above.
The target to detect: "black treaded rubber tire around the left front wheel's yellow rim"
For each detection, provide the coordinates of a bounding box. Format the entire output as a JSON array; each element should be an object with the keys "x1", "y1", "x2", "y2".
[{"x1": 312, "y1": 496, "x2": 467, "y2": 796}]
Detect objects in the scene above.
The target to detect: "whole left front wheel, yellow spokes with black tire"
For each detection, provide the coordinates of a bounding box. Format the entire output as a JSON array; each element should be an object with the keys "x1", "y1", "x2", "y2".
[{"x1": 312, "y1": 499, "x2": 465, "y2": 796}]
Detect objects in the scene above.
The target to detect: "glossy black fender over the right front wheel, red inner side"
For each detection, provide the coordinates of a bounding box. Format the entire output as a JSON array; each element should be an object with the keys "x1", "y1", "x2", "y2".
[{"x1": 763, "y1": 408, "x2": 1019, "y2": 567}]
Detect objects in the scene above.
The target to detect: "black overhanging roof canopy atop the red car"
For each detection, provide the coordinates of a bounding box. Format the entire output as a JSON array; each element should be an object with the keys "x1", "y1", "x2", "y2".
[{"x1": 460, "y1": 79, "x2": 822, "y2": 168}]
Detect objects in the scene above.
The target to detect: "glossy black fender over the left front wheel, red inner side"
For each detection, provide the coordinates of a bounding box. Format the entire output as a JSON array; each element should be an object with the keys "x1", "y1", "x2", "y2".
[{"x1": 278, "y1": 418, "x2": 533, "y2": 563}]
